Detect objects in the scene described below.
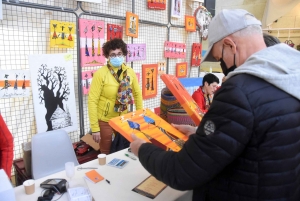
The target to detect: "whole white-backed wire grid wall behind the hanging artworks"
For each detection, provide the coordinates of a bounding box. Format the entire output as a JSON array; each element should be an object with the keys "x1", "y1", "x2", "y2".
[{"x1": 0, "y1": 0, "x2": 204, "y2": 174}]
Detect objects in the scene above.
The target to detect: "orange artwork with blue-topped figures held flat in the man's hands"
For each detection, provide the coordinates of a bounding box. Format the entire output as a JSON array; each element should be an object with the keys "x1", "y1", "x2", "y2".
[{"x1": 108, "y1": 109, "x2": 188, "y2": 151}]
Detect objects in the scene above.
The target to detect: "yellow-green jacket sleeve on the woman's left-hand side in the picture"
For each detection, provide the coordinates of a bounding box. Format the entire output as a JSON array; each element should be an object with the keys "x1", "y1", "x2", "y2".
[{"x1": 88, "y1": 71, "x2": 103, "y2": 132}]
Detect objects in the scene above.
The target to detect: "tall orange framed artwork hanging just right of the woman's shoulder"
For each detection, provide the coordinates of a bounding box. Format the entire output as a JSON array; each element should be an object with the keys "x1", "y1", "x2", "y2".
[{"x1": 142, "y1": 64, "x2": 157, "y2": 99}]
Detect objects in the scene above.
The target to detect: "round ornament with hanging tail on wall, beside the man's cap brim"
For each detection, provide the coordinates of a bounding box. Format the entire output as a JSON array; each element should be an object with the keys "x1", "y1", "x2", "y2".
[{"x1": 194, "y1": 6, "x2": 212, "y2": 40}]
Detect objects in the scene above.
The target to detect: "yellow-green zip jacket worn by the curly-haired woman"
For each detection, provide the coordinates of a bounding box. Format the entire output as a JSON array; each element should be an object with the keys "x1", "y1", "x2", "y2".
[{"x1": 88, "y1": 64, "x2": 143, "y2": 132}]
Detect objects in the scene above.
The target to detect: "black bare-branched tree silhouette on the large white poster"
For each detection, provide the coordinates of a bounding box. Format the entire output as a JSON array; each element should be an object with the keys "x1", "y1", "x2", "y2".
[{"x1": 37, "y1": 64, "x2": 72, "y2": 131}]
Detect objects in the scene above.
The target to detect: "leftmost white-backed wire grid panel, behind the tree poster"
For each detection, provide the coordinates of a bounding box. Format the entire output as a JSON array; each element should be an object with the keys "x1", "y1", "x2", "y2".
[{"x1": 0, "y1": 4, "x2": 80, "y2": 163}]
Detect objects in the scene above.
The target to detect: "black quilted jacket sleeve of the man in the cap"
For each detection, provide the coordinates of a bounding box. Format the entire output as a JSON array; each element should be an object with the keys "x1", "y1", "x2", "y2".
[{"x1": 138, "y1": 86, "x2": 254, "y2": 190}]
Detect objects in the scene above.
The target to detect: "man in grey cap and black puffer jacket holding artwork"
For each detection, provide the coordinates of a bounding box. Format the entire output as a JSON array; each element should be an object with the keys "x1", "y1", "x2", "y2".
[{"x1": 130, "y1": 9, "x2": 300, "y2": 201}]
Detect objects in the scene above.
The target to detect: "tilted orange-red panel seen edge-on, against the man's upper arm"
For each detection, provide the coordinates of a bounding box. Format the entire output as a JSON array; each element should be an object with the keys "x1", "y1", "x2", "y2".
[{"x1": 160, "y1": 74, "x2": 204, "y2": 125}]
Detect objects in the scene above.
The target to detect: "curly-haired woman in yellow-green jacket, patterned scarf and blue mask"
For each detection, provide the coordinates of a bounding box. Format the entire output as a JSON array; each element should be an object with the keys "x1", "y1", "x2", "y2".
[{"x1": 88, "y1": 38, "x2": 143, "y2": 154}]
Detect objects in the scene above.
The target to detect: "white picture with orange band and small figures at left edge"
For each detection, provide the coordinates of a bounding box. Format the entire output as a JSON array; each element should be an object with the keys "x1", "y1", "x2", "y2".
[{"x1": 0, "y1": 70, "x2": 31, "y2": 98}]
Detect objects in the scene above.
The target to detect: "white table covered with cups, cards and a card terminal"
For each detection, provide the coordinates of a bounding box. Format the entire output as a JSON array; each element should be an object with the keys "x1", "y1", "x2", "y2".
[{"x1": 14, "y1": 149, "x2": 192, "y2": 201}]
